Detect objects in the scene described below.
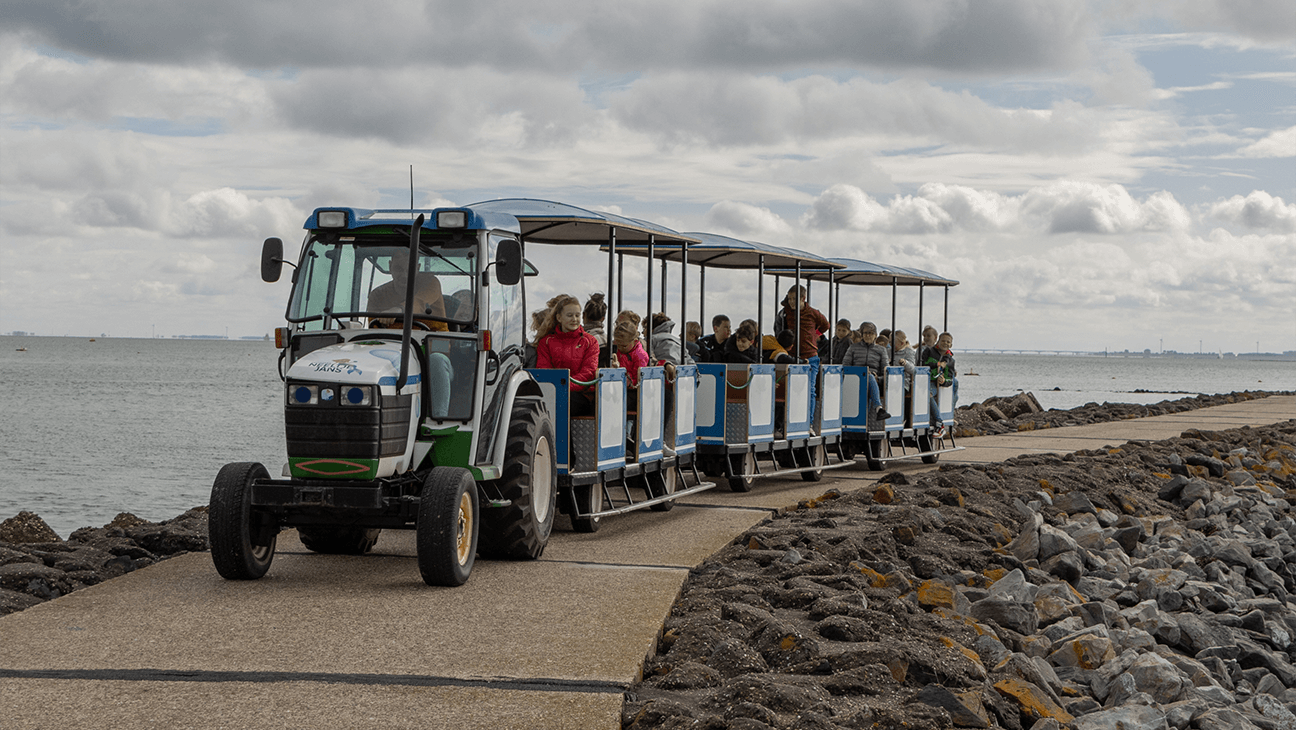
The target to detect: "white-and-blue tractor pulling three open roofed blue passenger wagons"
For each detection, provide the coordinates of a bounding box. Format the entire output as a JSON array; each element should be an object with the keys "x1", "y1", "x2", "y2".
[{"x1": 210, "y1": 200, "x2": 959, "y2": 585}]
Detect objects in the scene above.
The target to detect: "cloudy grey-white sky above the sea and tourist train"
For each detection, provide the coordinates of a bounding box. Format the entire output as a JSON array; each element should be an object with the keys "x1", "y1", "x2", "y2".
[{"x1": 0, "y1": 0, "x2": 1296, "y2": 353}]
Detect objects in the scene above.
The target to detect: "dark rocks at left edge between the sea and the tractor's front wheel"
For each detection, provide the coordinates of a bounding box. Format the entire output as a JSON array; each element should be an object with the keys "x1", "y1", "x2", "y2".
[{"x1": 0, "y1": 507, "x2": 207, "y2": 616}]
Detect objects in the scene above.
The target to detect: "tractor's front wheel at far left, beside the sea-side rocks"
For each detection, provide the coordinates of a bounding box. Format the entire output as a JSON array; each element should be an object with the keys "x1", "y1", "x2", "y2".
[{"x1": 207, "y1": 462, "x2": 279, "y2": 581}]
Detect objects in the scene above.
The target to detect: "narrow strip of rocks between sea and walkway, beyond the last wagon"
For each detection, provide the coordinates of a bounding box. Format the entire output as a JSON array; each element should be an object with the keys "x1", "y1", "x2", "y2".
[{"x1": 954, "y1": 390, "x2": 1291, "y2": 437}]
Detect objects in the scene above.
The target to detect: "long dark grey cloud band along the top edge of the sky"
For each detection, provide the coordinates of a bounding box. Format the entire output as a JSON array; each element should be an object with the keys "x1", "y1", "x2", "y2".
[{"x1": 6, "y1": 0, "x2": 1093, "y2": 73}]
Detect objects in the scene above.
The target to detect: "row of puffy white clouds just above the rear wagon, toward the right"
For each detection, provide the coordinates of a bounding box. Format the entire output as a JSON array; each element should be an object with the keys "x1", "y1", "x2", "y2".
[{"x1": 801, "y1": 182, "x2": 1192, "y2": 235}]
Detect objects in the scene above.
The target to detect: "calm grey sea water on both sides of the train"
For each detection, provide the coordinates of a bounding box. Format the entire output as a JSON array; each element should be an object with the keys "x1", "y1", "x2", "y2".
[{"x1": 0, "y1": 337, "x2": 1296, "y2": 537}]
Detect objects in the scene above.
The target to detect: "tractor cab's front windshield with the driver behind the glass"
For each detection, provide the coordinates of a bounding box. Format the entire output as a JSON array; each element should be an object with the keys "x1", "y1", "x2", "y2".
[{"x1": 288, "y1": 231, "x2": 477, "y2": 331}]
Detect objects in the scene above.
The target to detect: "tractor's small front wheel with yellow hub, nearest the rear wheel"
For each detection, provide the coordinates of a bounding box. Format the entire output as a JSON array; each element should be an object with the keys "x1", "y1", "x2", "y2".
[{"x1": 415, "y1": 467, "x2": 481, "y2": 586}]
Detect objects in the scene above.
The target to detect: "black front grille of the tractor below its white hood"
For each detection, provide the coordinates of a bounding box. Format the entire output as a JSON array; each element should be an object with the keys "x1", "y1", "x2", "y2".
[{"x1": 284, "y1": 395, "x2": 413, "y2": 459}]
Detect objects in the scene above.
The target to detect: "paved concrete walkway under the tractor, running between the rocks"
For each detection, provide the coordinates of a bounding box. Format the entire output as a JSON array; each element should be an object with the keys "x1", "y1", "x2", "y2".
[{"x1": 0, "y1": 397, "x2": 1296, "y2": 730}]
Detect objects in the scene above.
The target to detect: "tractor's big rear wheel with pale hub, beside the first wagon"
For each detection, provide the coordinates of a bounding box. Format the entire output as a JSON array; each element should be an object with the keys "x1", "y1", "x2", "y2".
[{"x1": 478, "y1": 401, "x2": 559, "y2": 560}]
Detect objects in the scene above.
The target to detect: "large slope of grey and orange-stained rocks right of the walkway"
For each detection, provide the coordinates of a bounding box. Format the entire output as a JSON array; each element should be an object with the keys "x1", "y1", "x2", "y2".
[{"x1": 622, "y1": 421, "x2": 1296, "y2": 730}]
